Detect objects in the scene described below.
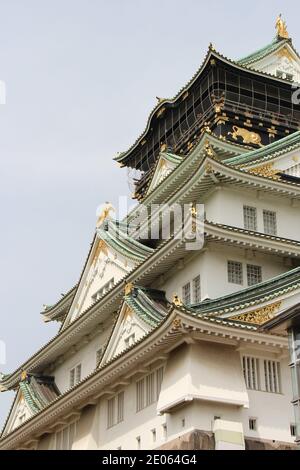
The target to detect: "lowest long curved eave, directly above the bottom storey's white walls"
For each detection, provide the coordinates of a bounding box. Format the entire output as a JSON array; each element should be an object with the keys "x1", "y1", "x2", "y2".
[{"x1": 0, "y1": 307, "x2": 287, "y2": 449}]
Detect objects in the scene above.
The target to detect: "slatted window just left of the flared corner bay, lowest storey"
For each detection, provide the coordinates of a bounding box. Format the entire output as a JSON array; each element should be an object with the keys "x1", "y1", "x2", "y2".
[{"x1": 136, "y1": 367, "x2": 163, "y2": 412}]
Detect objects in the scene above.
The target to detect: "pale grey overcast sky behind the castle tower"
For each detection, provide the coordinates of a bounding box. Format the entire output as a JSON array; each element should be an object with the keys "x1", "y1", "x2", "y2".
[{"x1": 0, "y1": 0, "x2": 300, "y2": 424}]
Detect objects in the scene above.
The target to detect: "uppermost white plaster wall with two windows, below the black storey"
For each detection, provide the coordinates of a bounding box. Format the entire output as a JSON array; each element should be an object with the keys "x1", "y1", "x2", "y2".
[{"x1": 205, "y1": 187, "x2": 300, "y2": 240}]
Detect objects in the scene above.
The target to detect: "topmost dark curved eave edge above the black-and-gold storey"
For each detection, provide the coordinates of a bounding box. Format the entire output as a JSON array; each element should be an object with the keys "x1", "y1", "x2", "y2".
[{"x1": 114, "y1": 48, "x2": 293, "y2": 165}]
